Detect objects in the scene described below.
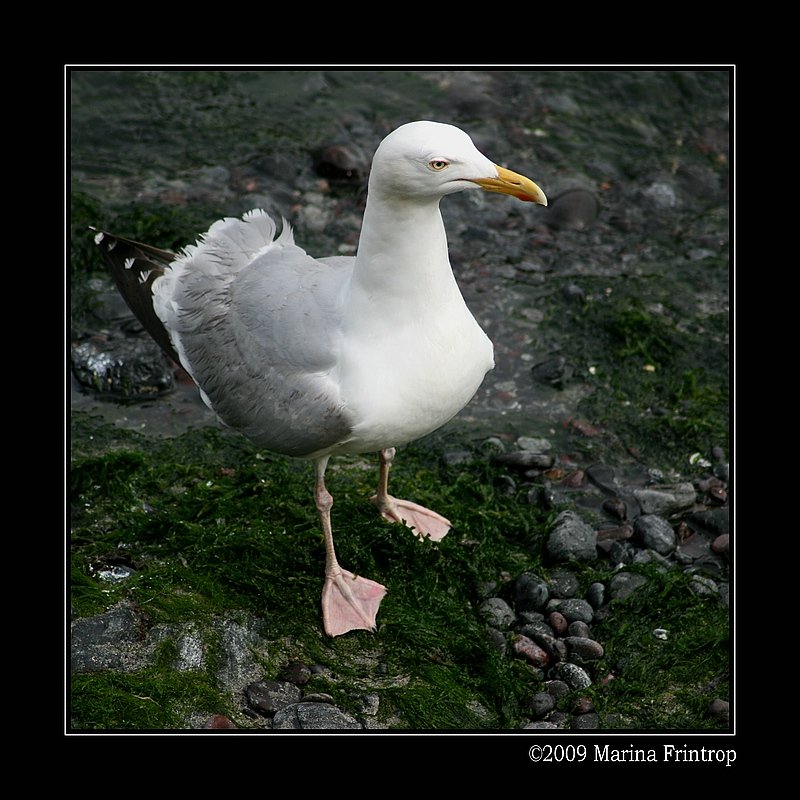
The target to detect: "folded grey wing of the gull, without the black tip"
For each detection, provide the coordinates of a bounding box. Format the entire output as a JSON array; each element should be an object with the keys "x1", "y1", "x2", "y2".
[{"x1": 175, "y1": 246, "x2": 353, "y2": 456}]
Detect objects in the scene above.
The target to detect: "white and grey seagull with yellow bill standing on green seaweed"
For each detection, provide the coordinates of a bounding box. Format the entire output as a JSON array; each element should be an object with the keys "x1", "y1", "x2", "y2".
[{"x1": 95, "y1": 120, "x2": 547, "y2": 636}]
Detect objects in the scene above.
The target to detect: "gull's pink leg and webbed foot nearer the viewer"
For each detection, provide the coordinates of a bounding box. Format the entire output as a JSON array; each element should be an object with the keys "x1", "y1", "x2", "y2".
[{"x1": 314, "y1": 456, "x2": 386, "y2": 636}]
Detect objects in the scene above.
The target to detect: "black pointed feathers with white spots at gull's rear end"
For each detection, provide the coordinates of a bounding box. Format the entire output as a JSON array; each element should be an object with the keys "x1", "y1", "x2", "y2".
[{"x1": 92, "y1": 228, "x2": 181, "y2": 364}]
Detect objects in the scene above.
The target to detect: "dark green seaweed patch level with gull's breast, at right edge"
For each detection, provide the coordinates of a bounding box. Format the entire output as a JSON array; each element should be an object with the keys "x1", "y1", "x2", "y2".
[{"x1": 548, "y1": 277, "x2": 730, "y2": 473}]
